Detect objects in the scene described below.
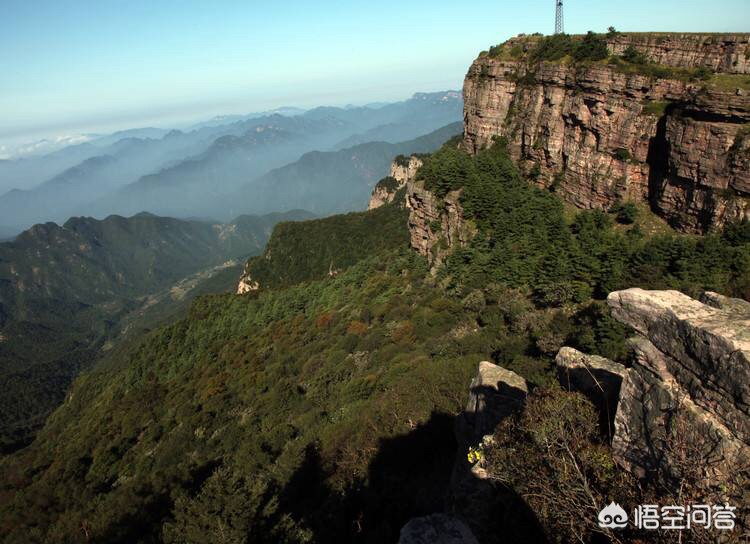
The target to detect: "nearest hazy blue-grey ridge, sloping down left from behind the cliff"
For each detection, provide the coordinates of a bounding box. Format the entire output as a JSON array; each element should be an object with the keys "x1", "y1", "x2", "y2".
[{"x1": 217, "y1": 123, "x2": 462, "y2": 217}]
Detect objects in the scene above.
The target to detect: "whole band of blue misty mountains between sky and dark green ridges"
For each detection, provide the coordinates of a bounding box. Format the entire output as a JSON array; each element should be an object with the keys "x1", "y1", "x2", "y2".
[{"x1": 0, "y1": 91, "x2": 463, "y2": 239}]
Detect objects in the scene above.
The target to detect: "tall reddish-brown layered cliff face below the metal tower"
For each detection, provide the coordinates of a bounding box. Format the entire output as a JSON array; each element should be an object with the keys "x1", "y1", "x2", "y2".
[{"x1": 464, "y1": 34, "x2": 750, "y2": 232}]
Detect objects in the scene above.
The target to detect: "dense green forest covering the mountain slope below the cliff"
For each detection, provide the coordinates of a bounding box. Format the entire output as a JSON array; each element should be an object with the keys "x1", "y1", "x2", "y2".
[{"x1": 0, "y1": 141, "x2": 750, "y2": 544}]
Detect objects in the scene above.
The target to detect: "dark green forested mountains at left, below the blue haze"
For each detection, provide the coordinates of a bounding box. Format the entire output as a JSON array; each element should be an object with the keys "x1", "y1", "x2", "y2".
[{"x1": 0, "y1": 211, "x2": 311, "y2": 450}]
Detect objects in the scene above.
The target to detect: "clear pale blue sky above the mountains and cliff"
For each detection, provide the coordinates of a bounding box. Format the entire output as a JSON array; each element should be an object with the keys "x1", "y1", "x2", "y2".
[{"x1": 0, "y1": 0, "x2": 750, "y2": 155}]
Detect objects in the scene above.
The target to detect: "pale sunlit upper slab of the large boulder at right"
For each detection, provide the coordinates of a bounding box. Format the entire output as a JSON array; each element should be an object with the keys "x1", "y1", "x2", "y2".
[{"x1": 607, "y1": 289, "x2": 750, "y2": 442}]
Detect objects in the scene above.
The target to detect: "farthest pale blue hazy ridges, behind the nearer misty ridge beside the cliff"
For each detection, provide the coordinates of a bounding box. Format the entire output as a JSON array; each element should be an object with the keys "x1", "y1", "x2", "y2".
[{"x1": 0, "y1": 91, "x2": 463, "y2": 228}]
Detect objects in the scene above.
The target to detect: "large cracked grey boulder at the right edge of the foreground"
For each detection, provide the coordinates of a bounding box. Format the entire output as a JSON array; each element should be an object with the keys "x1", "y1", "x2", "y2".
[{"x1": 557, "y1": 289, "x2": 750, "y2": 487}]
